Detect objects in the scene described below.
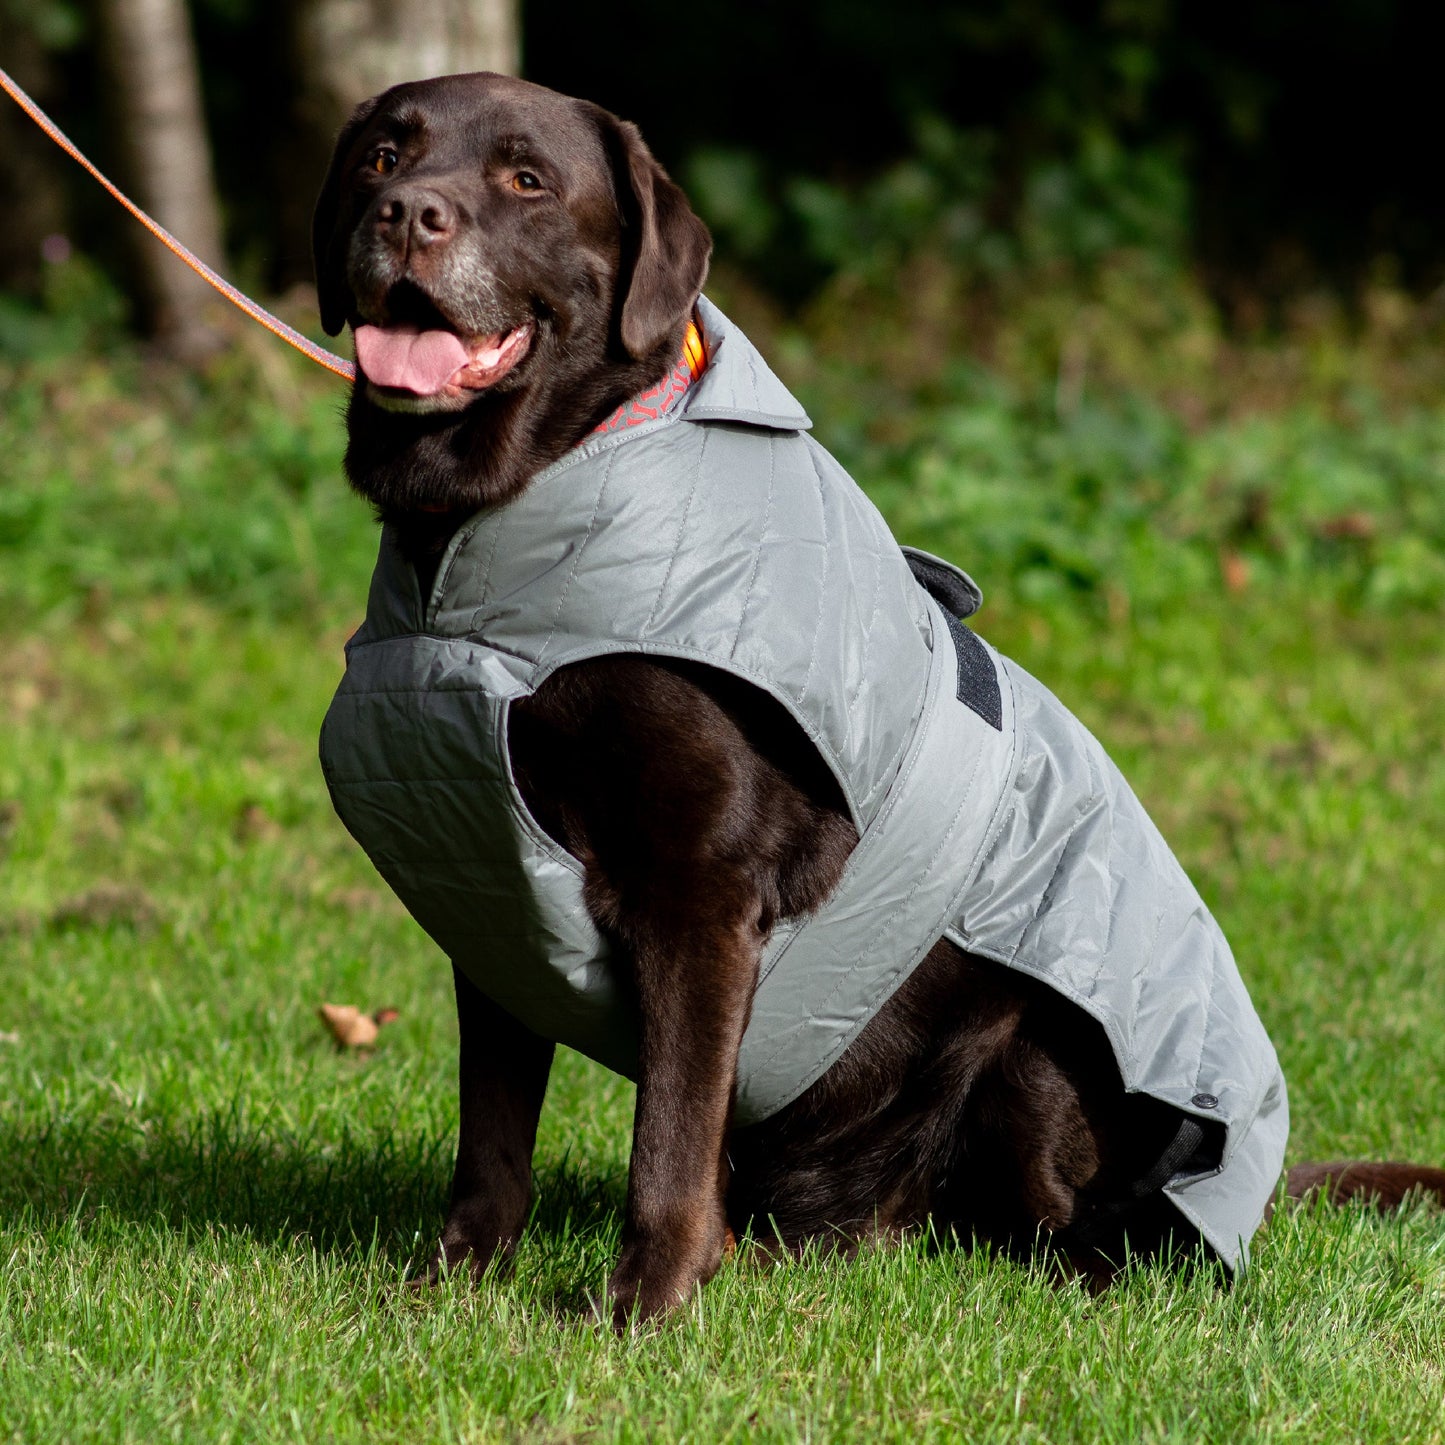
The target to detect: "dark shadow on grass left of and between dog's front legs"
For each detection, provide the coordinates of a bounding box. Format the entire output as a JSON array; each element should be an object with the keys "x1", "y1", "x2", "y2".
[{"x1": 0, "y1": 1107, "x2": 624, "y2": 1283}]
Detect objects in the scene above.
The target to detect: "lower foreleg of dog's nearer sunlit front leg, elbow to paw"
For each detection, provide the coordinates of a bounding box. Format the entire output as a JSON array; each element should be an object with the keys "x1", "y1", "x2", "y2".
[{"x1": 608, "y1": 907, "x2": 760, "y2": 1329}]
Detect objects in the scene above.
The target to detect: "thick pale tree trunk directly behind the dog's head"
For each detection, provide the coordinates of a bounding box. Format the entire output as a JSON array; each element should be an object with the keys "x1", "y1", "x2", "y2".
[{"x1": 277, "y1": 0, "x2": 522, "y2": 282}]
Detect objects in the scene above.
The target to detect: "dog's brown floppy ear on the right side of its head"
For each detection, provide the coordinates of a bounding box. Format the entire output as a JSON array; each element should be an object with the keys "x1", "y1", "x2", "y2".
[{"x1": 597, "y1": 108, "x2": 712, "y2": 357}]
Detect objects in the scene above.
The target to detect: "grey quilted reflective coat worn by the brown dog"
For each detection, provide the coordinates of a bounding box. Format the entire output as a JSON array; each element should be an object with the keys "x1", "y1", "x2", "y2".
[{"x1": 321, "y1": 302, "x2": 1287, "y2": 1264}]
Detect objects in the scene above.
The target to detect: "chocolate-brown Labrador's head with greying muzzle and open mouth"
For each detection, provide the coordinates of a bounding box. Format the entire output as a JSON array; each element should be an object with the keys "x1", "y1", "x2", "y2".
[{"x1": 312, "y1": 74, "x2": 709, "y2": 514}]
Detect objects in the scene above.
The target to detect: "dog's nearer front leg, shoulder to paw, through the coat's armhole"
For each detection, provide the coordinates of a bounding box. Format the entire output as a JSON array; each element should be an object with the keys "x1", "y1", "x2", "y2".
[{"x1": 509, "y1": 657, "x2": 814, "y2": 1327}]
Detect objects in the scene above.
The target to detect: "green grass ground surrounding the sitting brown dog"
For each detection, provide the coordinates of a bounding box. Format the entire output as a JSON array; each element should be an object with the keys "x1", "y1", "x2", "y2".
[{"x1": 0, "y1": 290, "x2": 1445, "y2": 1442}]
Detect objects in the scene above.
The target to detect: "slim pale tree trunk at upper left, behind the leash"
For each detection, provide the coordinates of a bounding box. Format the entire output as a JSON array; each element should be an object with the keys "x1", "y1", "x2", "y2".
[{"x1": 97, "y1": 0, "x2": 223, "y2": 360}]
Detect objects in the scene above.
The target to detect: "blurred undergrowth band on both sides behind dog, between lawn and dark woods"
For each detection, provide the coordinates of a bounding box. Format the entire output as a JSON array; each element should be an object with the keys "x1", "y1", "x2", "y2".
[{"x1": 0, "y1": 245, "x2": 1445, "y2": 630}]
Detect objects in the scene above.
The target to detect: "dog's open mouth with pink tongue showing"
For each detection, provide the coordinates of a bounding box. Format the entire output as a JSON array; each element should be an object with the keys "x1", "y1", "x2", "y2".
[{"x1": 353, "y1": 286, "x2": 536, "y2": 412}]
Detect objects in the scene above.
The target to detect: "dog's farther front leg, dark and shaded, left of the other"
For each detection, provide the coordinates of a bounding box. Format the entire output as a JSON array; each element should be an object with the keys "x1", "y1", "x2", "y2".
[{"x1": 436, "y1": 965, "x2": 553, "y2": 1274}]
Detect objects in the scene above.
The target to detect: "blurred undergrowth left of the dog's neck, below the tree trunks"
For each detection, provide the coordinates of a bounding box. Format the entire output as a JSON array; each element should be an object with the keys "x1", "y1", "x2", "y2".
[{"x1": 0, "y1": 257, "x2": 374, "y2": 616}]
